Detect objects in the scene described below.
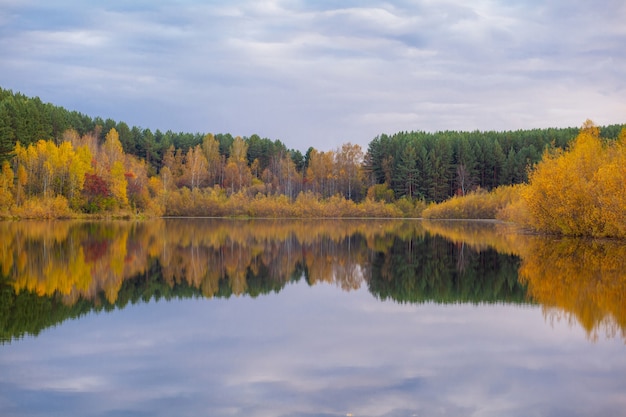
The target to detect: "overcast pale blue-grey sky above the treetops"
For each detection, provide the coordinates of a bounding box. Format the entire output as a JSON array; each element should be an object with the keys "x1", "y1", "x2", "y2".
[{"x1": 0, "y1": 0, "x2": 626, "y2": 151}]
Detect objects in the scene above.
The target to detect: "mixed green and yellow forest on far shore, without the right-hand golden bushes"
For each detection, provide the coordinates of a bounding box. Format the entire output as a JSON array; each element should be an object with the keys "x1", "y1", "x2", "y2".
[{"x1": 0, "y1": 89, "x2": 624, "y2": 231}]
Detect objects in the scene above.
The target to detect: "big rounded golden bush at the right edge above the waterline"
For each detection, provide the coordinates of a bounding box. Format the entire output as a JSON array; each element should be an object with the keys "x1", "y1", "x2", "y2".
[{"x1": 522, "y1": 122, "x2": 626, "y2": 237}]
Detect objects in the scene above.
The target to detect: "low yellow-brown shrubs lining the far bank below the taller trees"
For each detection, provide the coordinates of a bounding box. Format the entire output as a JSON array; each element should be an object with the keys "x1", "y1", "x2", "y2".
[{"x1": 0, "y1": 188, "x2": 426, "y2": 219}]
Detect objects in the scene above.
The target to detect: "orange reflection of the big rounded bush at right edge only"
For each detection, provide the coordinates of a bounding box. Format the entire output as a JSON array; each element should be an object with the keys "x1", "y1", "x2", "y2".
[{"x1": 519, "y1": 238, "x2": 626, "y2": 340}]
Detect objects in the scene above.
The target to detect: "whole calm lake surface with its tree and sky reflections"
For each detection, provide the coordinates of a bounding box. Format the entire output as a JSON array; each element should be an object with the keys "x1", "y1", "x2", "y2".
[{"x1": 0, "y1": 219, "x2": 626, "y2": 417}]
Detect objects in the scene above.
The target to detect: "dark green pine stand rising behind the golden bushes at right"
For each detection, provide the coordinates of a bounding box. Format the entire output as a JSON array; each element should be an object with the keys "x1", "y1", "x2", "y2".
[{"x1": 365, "y1": 125, "x2": 623, "y2": 202}]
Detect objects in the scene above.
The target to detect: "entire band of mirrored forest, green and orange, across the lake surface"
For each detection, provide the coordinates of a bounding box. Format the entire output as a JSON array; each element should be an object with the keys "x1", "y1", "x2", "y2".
[{"x1": 0, "y1": 219, "x2": 626, "y2": 340}]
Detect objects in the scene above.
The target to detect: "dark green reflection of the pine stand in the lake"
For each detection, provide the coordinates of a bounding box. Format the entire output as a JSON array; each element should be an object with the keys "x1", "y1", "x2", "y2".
[{"x1": 369, "y1": 234, "x2": 526, "y2": 303}]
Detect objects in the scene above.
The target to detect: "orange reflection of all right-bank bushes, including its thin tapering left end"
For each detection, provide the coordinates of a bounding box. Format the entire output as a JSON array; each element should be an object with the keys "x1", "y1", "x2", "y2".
[{"x1": 424, "y1": 222, "x2": 626, "y2": 340}]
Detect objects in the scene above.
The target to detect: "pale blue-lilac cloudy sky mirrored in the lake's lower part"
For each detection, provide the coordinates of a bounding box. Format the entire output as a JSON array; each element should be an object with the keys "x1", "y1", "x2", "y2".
[{"x1": 0, "y1": 219, "x2": 626, "y2": 417}]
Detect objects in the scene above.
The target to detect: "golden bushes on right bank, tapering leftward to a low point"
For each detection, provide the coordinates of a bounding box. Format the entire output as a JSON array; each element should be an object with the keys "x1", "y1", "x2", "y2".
[{"x1": 422, "y1": 120, "x2": 626, "y2": 239}]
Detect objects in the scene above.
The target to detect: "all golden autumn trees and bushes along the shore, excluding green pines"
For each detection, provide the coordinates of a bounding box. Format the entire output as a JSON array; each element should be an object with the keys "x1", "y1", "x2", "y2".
[{"x1": 0, "y1": 121, "x2": 626, "y2": 226}]
